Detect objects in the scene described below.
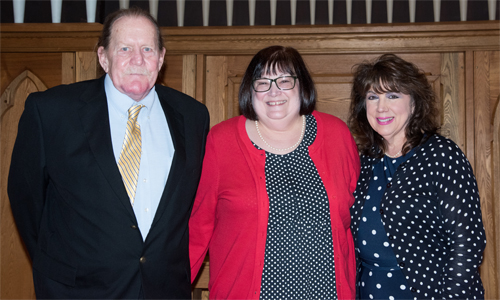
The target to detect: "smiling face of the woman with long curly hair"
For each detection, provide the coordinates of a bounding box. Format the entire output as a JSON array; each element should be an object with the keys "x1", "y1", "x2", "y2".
[{"x1": 365, "y1": 90, "x2": 412, "y2": 146}]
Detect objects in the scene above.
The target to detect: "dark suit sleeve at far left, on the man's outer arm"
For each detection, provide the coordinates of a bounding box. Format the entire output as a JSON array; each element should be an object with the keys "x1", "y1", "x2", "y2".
[{"x1": 7, "y1": 94, "x2": 48, "y2": 259}]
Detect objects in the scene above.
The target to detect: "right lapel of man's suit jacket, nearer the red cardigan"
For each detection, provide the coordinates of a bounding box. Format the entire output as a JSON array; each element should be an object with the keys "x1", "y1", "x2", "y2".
[{"x1": 151, "y1": 87, "x2": 186, "y2": 229}]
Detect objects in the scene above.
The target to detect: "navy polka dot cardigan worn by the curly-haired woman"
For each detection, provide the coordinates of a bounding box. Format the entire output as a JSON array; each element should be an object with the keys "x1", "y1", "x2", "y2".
[{"x1": 351, "y1": 135, "x2": 486, "y2": 299}]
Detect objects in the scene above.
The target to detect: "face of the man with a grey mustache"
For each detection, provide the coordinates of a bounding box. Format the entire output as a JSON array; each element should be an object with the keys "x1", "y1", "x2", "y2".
[{"x1": 97, "y1": 17, "x2": 165, "y2": 101}]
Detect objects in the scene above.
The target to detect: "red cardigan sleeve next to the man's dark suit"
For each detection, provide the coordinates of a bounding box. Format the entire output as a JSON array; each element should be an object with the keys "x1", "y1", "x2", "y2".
[{"x1": 189, "y1": 131, "x2": 219, "y2": 282}]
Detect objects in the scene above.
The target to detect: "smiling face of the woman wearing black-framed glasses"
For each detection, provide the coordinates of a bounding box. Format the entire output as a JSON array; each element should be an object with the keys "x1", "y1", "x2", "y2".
[{"x1": 252, "y1": 72, "x2": 300, "y2": 122}]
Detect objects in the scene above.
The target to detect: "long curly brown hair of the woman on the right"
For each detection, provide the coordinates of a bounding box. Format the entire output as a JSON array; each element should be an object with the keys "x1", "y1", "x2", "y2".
[{"x1": 347, "y1": 54, "x2": 439, "y2": 158}]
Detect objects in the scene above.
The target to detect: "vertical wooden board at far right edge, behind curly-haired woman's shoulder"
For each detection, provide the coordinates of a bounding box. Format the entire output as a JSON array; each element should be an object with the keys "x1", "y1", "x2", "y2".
[{"x1": 474, "y1": 51, "x2": 498, "y2": 299}]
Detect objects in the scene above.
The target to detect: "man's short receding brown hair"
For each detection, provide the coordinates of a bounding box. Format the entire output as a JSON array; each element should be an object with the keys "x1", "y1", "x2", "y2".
[{"x1": 97, "y1": 6, "x2": 163, "y2": 52}]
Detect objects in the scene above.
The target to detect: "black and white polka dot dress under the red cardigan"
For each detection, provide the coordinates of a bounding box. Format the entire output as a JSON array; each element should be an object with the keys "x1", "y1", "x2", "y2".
[{"x1": 256, "y1": 115, "x2": 337, "y2": 299}]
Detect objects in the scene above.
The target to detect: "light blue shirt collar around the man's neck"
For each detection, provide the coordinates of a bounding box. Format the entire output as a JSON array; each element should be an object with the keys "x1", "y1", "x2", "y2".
[{"x1": 104, "y1": 74, "x2": 158, "y2": 116}]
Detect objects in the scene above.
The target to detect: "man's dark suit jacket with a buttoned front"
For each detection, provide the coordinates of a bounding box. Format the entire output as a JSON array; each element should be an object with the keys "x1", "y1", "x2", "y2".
[{"x1": 8, "y1": 77, "x2": 209, "y2": 299}]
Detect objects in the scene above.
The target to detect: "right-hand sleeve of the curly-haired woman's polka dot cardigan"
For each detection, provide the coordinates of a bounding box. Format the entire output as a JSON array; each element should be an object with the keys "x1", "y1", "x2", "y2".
[{"x1": 435, "y1": 140, "x2": 486, "y2": 299}]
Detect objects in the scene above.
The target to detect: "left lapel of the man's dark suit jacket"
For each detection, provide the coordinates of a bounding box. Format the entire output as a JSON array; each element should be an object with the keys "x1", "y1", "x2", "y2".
[{"x1": 80, "y1": 77, "x2": 135, "y2": 218}]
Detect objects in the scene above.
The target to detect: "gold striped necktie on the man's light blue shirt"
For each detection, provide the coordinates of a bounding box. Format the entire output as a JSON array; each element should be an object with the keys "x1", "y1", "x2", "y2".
[{"x1": 118, "y1": 105, "x2": 144, "y2": 206}]
